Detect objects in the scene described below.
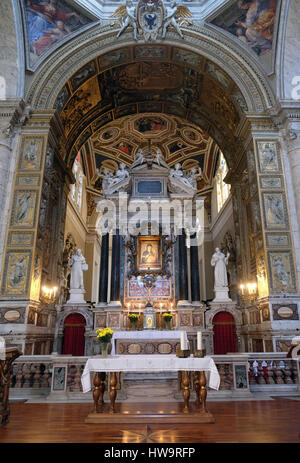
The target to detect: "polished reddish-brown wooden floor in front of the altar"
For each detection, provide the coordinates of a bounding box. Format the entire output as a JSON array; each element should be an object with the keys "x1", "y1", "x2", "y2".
[{"x1": 0, "y1": 399, "x2": 300, "y2": 443}]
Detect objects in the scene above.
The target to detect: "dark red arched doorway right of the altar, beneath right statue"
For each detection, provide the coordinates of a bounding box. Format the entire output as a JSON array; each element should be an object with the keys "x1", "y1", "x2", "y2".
[{"x1": 213, "y1": 312, "x2": 237, "y2": 355}]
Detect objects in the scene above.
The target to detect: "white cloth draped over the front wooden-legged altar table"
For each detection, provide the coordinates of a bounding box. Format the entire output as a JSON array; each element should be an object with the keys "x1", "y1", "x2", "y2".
[{"x1": 81, "y1": 355, "x2": 220, "y2": 392}]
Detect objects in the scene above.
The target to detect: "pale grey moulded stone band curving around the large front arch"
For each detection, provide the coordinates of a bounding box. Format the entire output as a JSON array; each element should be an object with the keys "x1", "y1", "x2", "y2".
[{"x1": 26, "y1": 25, "x2": 275, "y2": 112}]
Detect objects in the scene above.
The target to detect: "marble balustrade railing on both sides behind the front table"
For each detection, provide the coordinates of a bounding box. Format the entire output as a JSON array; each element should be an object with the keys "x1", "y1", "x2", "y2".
[{"x1": 10, "y1": 353, "x2": 300, "y2": 401}]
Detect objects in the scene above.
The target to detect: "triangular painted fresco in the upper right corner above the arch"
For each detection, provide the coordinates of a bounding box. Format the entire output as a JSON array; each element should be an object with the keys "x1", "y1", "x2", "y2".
[{"x1": 212, "y1": 0, "x2": 280, "y2": 56}]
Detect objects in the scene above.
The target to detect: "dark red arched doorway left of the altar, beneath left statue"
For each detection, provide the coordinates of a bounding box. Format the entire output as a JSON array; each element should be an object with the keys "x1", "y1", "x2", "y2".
[{"x1": 62, "y1": 313, "x2": 86, "y2": 356}]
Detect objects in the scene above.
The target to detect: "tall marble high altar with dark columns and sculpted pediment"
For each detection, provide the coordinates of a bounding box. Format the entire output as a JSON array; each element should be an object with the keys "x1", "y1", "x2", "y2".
[{"x1": 53, "y1": 140, "x2": 235, "y2": 356}]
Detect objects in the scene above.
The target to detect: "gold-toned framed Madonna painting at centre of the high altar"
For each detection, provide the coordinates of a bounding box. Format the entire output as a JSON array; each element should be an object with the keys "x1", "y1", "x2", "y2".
[{"x1": 138, "y1": 236, "x2": 161, "y2": 270}]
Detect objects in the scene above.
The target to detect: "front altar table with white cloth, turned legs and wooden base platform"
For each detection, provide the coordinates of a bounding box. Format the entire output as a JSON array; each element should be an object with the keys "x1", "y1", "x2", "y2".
[{"x1": 81, "y1": 355, "x2": 220, "y2": 424}]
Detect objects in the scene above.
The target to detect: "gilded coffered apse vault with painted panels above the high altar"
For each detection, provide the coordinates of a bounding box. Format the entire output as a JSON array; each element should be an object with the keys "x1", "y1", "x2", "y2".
[{"x1": 82, "y1": 113, "x2": 216, "y2": 196}]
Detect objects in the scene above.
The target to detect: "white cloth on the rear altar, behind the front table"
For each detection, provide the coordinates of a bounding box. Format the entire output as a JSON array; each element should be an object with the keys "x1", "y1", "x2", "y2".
[{"x1": 111, "y1": 330, "x2": 188, "y2": 355}]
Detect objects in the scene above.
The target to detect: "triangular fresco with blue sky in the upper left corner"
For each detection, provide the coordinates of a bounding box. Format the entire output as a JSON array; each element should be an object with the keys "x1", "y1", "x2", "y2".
[{"x1": 23, "y1": 0, "x2": 91, "y2": 64}]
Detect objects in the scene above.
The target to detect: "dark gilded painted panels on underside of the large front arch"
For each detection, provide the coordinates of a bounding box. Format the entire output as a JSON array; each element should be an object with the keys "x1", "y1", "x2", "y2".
[{"x1": 55, "y1": 45, "x2": 247, "y2": 167}]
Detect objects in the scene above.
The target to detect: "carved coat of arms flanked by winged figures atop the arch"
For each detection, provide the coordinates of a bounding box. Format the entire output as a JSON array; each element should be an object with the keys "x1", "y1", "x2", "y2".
[{"x1": 111, "y1": 0, "x2": 192, "y2": 42}]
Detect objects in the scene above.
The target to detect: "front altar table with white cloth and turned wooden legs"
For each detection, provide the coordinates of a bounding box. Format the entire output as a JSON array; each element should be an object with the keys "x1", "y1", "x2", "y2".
[{"x1": 81, "y1": 354, "x2": 220, "y2": 423}]
